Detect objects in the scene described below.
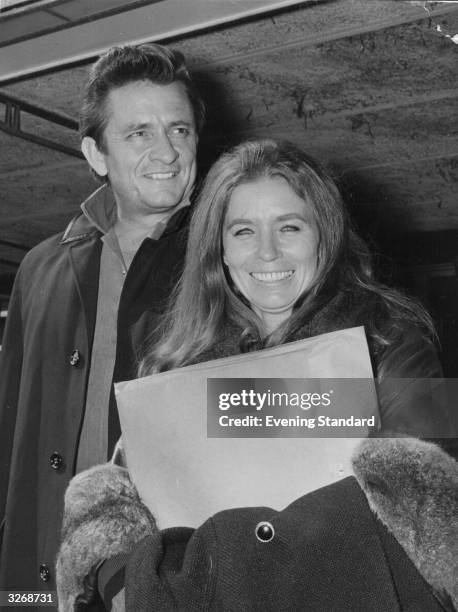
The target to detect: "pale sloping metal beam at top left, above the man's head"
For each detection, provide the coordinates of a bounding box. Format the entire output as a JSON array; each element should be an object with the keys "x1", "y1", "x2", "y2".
[{"x1": 0, "y1": 0, "x2": 314, "y2": 83}]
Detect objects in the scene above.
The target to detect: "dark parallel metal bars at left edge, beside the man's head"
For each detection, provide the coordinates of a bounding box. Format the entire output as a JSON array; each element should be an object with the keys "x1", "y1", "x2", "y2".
[{"x1": 0, "y1": 93, "x2": 83, "y2": 159}]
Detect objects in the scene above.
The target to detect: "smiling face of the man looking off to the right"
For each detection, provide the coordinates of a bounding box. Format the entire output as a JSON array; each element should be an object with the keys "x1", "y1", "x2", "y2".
[{"x1": 94, "y1": 81, "x2": 197, "y2": 219}]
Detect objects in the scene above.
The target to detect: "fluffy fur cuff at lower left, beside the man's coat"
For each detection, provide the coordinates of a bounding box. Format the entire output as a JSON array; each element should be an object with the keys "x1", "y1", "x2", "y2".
[{"x1": 56, "y1": 464, "x2": 157, "y2": 612}]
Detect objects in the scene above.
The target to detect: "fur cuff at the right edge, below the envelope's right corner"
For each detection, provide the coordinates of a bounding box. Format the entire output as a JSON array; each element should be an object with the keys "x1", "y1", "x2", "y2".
[{"x1": 352, "y1": 438, "x2": 458, "y2": 608}]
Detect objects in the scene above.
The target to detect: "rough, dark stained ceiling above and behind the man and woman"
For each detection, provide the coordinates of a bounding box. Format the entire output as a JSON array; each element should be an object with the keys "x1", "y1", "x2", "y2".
[{"x1": 0, "y1": 0, "x2": 458, "y2": 293}]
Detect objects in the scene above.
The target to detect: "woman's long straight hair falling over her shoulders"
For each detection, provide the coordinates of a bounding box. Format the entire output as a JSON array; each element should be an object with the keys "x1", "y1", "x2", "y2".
[{"x1": 139, "y1": 140, "x2": 434, "y2": 376}]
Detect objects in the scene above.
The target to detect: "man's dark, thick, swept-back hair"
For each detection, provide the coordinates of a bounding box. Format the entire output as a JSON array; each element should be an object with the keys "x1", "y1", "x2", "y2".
[{"x1": 80, "y1": 43, "x2": 205, "y2": 150}]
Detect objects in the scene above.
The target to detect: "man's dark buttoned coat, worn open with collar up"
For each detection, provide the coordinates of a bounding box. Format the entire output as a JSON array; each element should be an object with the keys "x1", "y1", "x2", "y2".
[{"x1": 0, "y1": 204, "x2": 188, "y2": 590}]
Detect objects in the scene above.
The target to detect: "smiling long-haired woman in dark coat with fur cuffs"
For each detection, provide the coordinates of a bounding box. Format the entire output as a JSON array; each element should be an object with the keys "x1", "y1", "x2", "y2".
[{"x1": 57, "y1": 140, "x2": 458, "y2": 612}]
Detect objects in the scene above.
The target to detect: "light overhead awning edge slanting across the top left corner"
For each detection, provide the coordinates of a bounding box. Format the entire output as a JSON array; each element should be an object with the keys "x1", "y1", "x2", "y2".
[{"x1": 0, "y1": 0, "x2": 316, "y2": 84}]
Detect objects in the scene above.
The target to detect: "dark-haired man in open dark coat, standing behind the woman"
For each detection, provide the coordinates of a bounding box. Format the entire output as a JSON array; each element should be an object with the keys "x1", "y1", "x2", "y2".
[{"x1": 0, "y1": 45, "x2": 204, "y2": 591}]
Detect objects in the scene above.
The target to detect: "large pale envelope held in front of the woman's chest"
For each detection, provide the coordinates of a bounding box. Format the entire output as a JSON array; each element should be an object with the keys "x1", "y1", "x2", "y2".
[{"x1": 115, "y1": 327, "x2": 377, "y2": 528}]
